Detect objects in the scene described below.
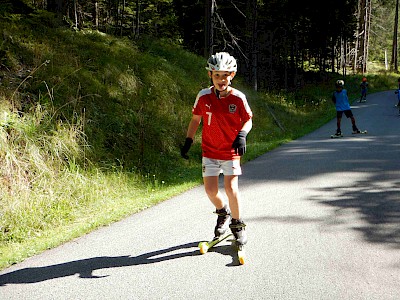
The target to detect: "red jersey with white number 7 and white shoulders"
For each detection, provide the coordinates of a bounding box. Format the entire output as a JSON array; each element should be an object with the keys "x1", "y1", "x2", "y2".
[{"x1": 192, "y1": 87, "x2": 253, "y2": 160}]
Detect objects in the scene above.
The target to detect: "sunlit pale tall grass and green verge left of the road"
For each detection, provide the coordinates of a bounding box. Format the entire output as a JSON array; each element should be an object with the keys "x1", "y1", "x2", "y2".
[{"x1": 0, "y1": 92, "x2": 200, "y2": 267}]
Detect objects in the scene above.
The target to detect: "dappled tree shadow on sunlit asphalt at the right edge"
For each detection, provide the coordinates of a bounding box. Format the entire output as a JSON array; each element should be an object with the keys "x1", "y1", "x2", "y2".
[{"x1": 310, "y1": 175, "x2": 400, "y2": 249}]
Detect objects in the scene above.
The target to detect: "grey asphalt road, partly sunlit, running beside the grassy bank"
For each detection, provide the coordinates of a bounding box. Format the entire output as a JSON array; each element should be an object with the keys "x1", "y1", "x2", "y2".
[{"x1": 0, "y1": 91, "x2": 400, "y2": 300}]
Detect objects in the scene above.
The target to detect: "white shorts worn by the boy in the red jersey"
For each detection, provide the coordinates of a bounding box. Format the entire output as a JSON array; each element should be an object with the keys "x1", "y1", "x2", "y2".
[{"x1": 202, "y1": 157, "x2": 242, "y2": 177}]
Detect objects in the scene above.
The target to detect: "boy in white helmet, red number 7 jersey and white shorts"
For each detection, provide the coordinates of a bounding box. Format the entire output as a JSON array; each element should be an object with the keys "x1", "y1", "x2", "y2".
[{"x1": 181, "y1": 52, "x2": 253, "y2": 246}]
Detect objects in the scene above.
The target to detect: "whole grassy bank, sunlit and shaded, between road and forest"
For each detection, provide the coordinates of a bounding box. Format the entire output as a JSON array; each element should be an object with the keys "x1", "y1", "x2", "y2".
[{"x1": 0, "y1": 14, "x2": 397, "y2": 269}]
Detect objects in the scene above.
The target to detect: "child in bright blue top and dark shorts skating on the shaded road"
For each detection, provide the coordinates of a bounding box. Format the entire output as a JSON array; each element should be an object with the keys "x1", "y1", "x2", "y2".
[{"x1": 332, "y1": 80, "x2": 361, "y2": 136}]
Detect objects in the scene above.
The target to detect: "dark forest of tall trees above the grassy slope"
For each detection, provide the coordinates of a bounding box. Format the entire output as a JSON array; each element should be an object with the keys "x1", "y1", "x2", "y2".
[{"x1": 3, "y1": 0, "x2": 398, "y2": 90}]
